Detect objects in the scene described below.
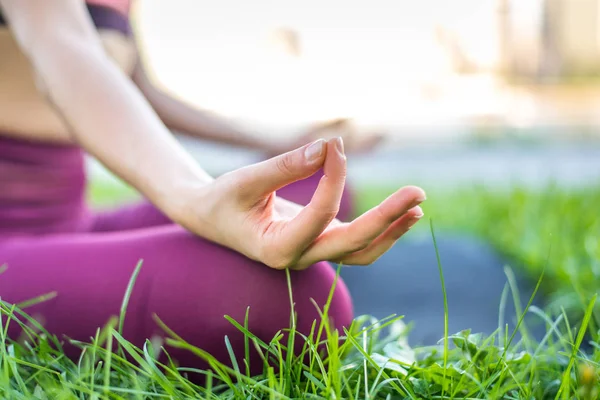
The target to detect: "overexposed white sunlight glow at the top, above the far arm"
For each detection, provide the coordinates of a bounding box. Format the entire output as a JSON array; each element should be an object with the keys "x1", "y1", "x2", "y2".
[{"x1": 137, "y1": 0, "x2": 504, "y2": 135}]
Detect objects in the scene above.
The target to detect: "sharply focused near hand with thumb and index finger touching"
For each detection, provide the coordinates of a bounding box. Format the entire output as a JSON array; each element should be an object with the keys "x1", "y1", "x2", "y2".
[{"x1": 176, "y1": 138, "x2": 425, "y2": 269}]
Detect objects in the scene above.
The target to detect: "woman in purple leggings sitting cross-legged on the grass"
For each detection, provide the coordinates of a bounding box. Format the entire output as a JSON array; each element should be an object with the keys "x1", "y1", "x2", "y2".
[{"x1": 0, "y1": 0, "x2": 425, "y2": 373}]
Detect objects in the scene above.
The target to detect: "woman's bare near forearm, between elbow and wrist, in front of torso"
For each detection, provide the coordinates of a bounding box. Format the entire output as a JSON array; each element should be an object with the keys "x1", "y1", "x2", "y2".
[{"x1": 30, "y1": 37, "x2": 211, "y2": 217}]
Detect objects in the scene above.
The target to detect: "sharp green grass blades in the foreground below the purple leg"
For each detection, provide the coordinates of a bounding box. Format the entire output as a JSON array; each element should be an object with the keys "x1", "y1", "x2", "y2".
[{"x1": 0, "y1": 248, "x2": 600, "y2": 399}]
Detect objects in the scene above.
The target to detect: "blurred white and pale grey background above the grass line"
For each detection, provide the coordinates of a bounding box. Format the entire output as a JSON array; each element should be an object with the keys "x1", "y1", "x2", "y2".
[{"x1": 91, "y1": 0, "x2": 600, "y2": 185}]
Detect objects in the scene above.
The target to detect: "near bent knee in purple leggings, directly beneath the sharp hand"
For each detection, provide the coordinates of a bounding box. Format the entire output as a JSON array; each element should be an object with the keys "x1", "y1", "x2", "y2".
[{"x1": 137, "y1": 235, "x2": 353, "y2": 372}]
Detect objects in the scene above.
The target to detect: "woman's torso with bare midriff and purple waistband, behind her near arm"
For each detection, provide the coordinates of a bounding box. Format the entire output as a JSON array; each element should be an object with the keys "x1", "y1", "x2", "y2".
[{"x1": 0, "y1": 0, "x2": 136, "y2": 236}]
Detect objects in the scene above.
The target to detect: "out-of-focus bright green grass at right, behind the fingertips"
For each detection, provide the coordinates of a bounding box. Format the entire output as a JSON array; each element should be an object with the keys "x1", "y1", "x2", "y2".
[{"x1": 359, "y1": 186, "x2": 600, "y2": 327}]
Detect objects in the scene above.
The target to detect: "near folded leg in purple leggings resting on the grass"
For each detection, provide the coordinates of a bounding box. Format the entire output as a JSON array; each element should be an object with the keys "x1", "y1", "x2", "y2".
[{"x1": 0, "y1": 225, "x2": 352, "y2": 371}]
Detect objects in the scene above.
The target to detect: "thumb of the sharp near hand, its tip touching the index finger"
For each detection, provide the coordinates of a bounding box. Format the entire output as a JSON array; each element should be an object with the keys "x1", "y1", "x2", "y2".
[{"x1": 239, "y1": 139, "x2": 327, "y2": 201}]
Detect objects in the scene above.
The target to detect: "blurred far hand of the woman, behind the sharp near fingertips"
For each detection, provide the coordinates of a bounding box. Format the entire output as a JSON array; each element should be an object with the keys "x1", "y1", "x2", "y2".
[{"x1": 267, "y1": 118, "x2": 384, "y2": 157}]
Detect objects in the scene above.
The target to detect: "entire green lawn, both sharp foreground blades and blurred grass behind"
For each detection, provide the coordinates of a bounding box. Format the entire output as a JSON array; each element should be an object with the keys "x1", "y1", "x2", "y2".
[{"x1": 0, "y1": 180, "x2": 600, "y2": 399}]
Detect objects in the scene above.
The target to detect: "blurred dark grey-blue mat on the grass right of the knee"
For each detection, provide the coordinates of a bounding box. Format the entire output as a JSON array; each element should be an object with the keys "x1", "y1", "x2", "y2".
[{"x1": 341, "y1": 234, "x2": 544, "y2": 345}]
